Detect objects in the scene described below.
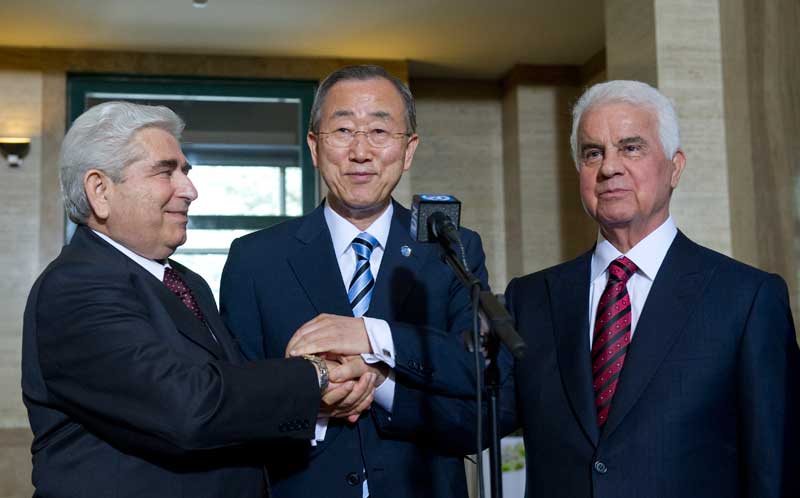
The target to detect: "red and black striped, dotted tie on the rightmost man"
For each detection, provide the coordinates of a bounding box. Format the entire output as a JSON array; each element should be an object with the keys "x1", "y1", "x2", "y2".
[{"x1": 592, "y1": 256, "x2": 637, "y2": 428}]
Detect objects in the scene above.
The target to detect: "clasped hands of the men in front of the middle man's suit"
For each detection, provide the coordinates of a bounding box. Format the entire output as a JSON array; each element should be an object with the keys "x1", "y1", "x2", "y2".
[{"x1": 286, "y1": 314, "x2": 389, "y2": 423}]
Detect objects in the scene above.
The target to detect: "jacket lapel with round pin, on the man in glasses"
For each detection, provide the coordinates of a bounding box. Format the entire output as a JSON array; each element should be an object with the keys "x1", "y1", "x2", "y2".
[{"x1": 366, "y1": 203, "x2": 437, "y2": 319}]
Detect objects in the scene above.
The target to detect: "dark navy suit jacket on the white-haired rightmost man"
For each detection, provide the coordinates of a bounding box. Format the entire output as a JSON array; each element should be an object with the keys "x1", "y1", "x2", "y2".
[{"x1": 505, "y1": 233, "x2": 800, "y2": 498}]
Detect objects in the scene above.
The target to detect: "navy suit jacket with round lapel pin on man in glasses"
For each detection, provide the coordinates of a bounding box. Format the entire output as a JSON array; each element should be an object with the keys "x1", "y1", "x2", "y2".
[{"x1": 221, "y1": 203, "x2": 487, "y2": 498}]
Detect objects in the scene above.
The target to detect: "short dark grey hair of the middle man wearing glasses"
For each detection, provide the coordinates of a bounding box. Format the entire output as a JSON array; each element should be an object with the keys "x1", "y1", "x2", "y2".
[{"x1": 308, "y1": 65, "x2": 417, "y2": 133}]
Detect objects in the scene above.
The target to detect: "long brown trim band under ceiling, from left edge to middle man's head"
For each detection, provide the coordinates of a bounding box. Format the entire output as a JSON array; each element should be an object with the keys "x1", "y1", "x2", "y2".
[{"x1": 0, "y1": 47, "x2": 408, "y2": 81}]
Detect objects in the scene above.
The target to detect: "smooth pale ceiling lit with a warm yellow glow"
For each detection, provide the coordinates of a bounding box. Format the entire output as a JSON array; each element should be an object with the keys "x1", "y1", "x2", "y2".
[{"x1": 0, "y1": 0, "x2": 605, "y2": 78}]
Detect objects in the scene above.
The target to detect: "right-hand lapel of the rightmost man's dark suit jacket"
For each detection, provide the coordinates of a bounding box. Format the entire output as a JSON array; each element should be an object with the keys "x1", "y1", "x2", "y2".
[{"x1": 603, "y1": 232, "x2": 713, "y2": 439}]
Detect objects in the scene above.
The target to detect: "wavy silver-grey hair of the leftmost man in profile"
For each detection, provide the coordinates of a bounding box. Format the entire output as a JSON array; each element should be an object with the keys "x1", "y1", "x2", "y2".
[{"x1": 59, "y1": 102, "x2": 185, "y2": 224}]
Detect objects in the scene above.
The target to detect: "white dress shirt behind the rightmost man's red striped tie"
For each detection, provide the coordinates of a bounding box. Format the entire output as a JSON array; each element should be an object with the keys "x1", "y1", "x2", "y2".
[{"x1": 589, "y1": 216, "x2": 678, "y2": 349}]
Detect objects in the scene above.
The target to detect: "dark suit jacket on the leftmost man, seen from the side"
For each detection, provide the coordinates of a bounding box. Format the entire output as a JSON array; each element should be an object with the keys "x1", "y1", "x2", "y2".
[{"x1": 22, "y1": 226, "x2": 320, "y2": 498}]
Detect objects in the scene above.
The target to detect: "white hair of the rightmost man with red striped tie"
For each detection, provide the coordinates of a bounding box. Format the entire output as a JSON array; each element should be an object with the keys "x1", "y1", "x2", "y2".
[{"x1": 569, "y1": 80, "x2": 681, "y2": 168}]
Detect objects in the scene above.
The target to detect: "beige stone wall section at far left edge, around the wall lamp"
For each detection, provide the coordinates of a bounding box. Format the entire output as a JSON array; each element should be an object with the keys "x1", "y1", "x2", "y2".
[{"x1": 0, "y1": 71, "x2": 46, "y2": 497}]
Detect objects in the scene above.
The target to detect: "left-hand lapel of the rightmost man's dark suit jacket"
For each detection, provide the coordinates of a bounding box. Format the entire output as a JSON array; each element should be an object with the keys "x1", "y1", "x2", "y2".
[{"x1": 547, "y1": 251, "x2": 600, "y2": 446}]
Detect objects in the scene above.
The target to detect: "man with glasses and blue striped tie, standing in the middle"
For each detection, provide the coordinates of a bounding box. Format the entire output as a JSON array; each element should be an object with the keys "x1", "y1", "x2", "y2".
[{"x1": 221, "y1": 66, "x2": 487, "y2": 498}]
